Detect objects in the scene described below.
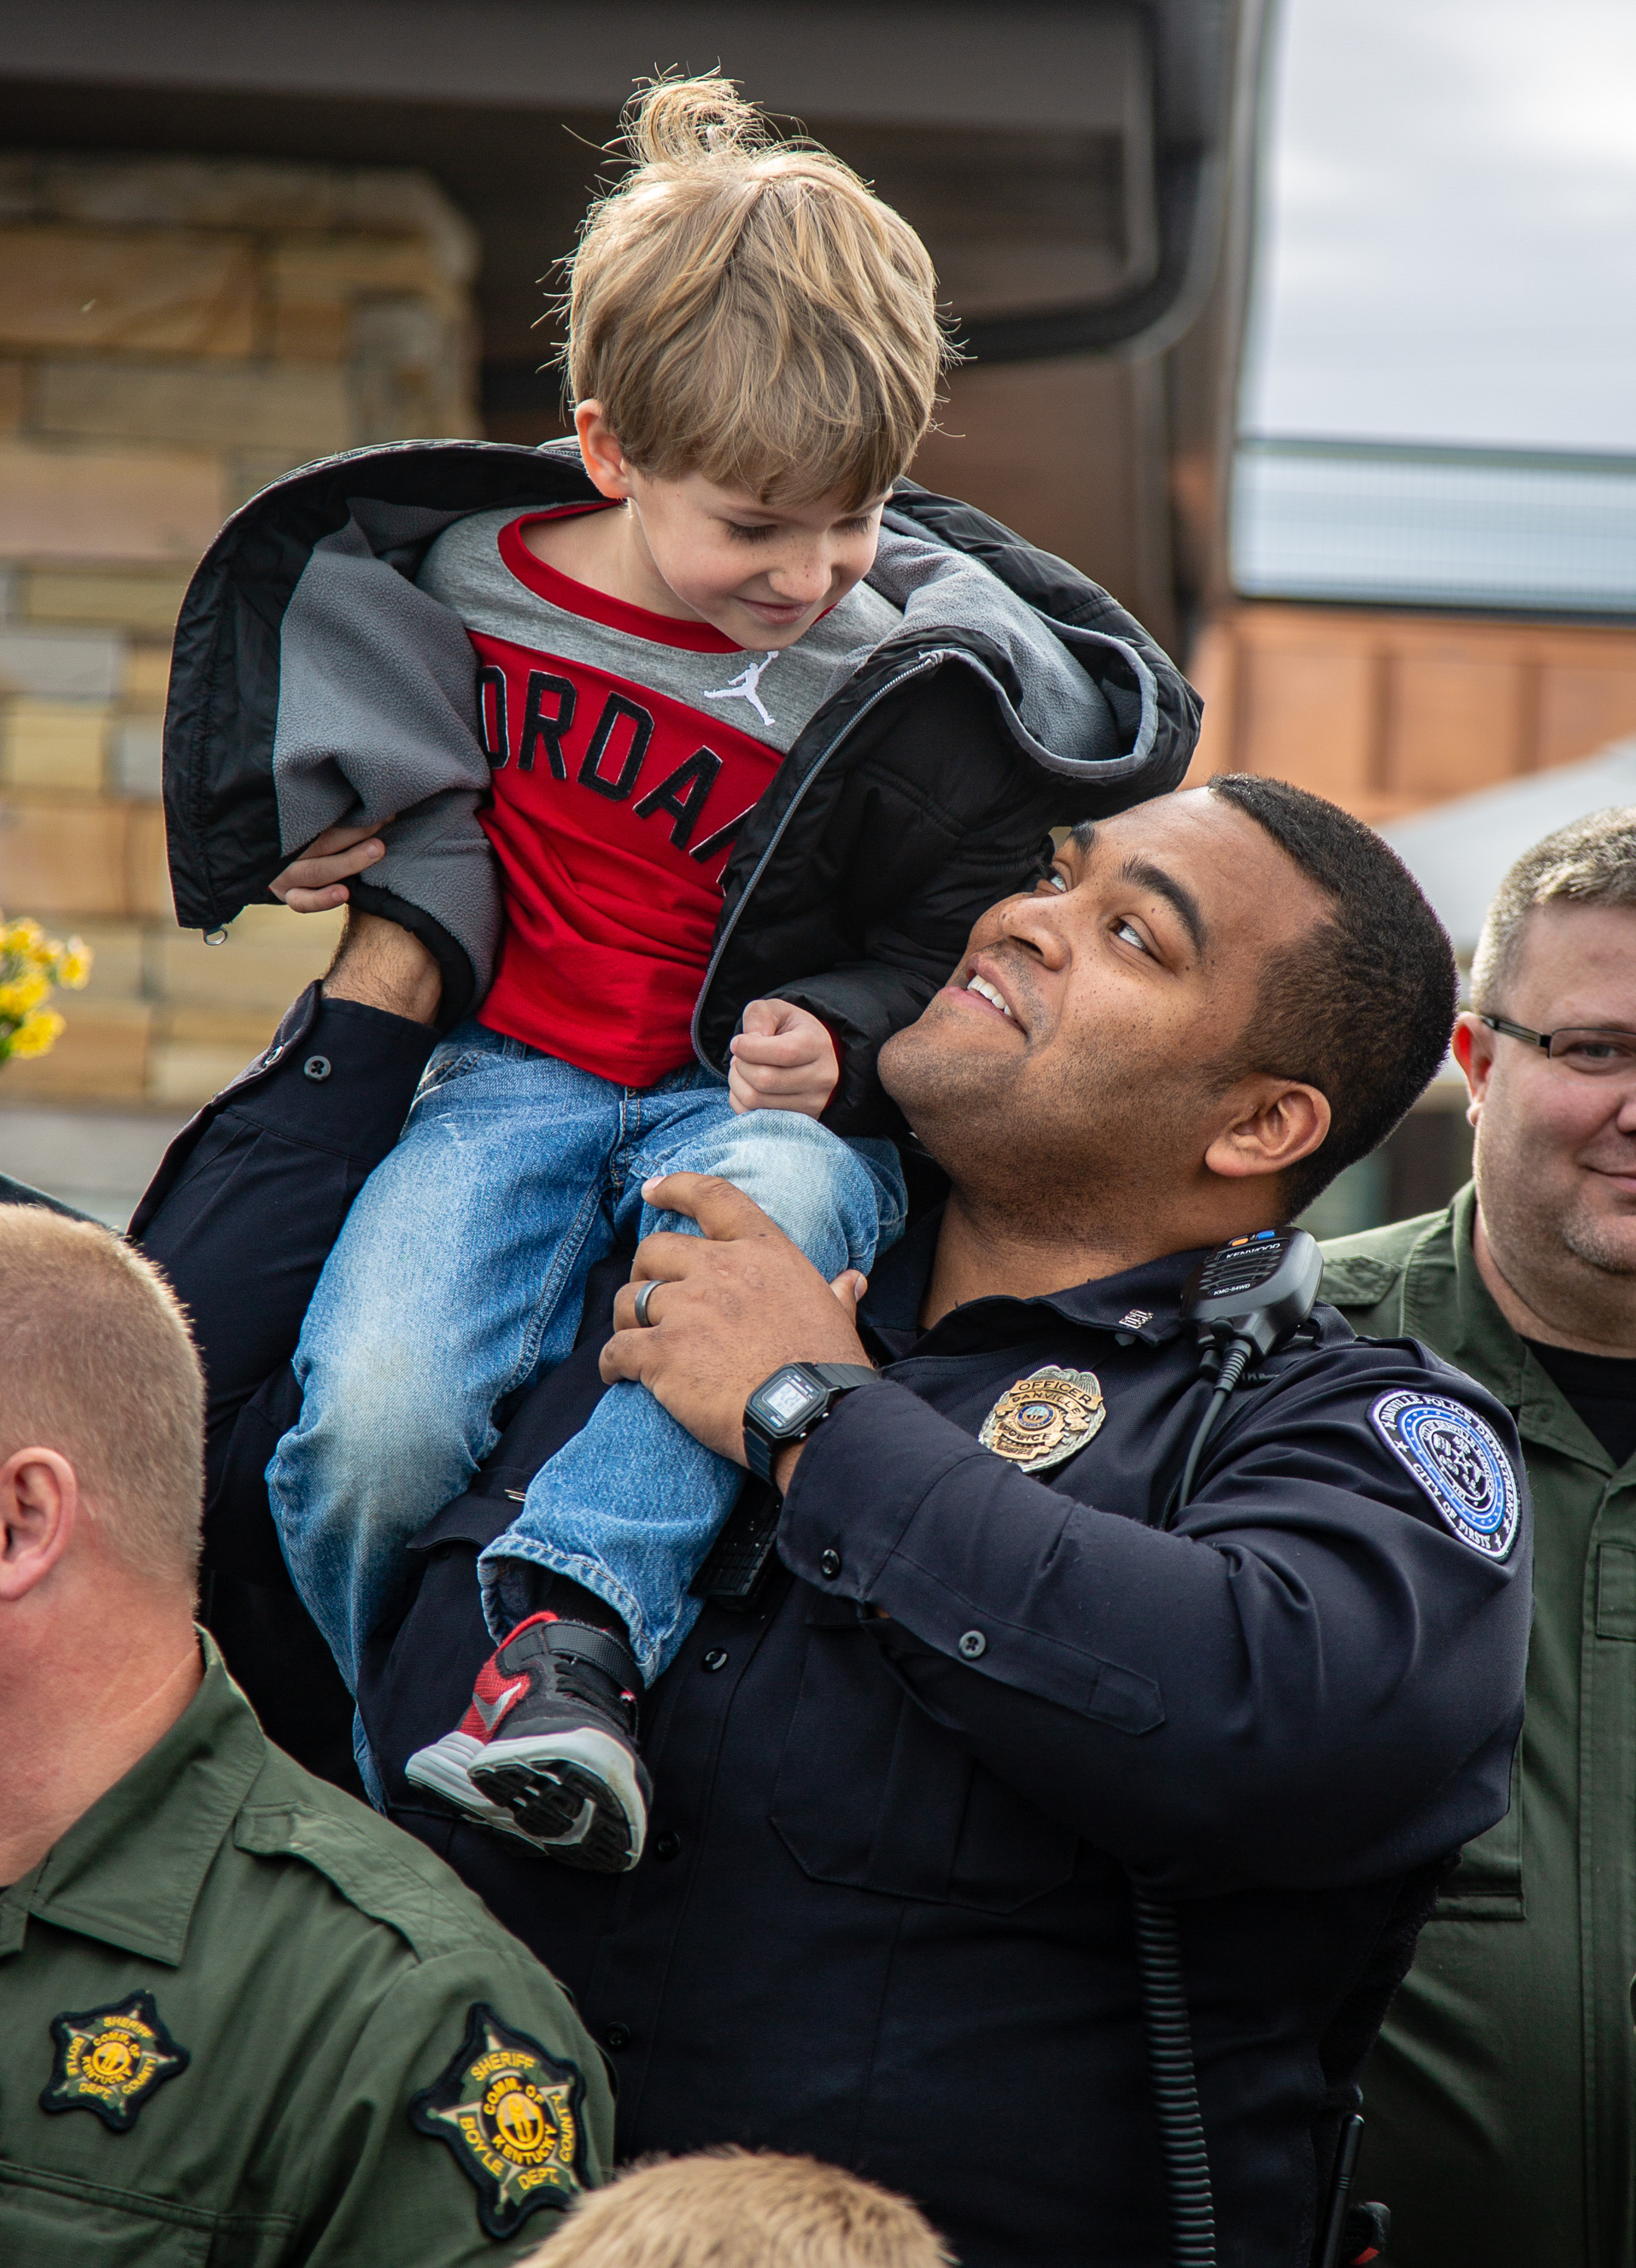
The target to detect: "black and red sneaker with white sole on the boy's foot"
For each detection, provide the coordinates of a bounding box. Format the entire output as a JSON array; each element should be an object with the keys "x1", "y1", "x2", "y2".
[{"x1": 406, "y1": 1615, "x2": 653, "y2": 1873}]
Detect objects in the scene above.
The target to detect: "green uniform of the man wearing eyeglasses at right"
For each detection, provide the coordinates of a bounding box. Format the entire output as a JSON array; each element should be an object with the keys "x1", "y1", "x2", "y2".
[{"x1": 1323, "y1": 1186, "x2": 1636, "y2": 2268}]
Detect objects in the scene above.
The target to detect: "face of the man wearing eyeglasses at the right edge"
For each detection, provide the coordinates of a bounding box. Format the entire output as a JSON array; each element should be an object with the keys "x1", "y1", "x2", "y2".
[{"x1": 1459, "y1": 903, "x2": 1636, "y2": 1297}]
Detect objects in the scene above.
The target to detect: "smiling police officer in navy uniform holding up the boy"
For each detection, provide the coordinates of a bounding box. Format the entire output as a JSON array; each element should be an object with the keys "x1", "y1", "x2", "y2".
[{"x1": 340, "y1": 778, "x2": 1529, "y2": 2268}]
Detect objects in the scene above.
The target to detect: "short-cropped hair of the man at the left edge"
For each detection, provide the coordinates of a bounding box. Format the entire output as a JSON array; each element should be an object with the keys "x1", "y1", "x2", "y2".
[{"x1": 0, "y1": 1204, "x2": 204, "y2": 1592}]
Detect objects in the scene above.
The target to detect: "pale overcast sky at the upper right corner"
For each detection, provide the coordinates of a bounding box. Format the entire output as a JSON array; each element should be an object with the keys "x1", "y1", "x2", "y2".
[{"x1": 1241, "y1": 0, "x2": 1636, "y2": 449}]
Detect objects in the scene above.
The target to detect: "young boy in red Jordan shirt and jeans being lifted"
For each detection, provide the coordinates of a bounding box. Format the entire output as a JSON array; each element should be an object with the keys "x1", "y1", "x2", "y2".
[{"x1": 255, "y1": 79, "x2": 1196, "y2": 1871}]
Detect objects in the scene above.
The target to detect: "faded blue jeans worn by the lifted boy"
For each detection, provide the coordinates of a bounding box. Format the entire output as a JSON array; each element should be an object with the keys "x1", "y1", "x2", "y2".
[{"x1": 268, "y1": 1023, "x2": 906, "y2": 1690}]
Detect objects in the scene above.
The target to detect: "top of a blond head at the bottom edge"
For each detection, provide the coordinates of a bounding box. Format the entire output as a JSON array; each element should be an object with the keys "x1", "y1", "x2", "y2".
[{"x1": 528, "y1": 2150, "x2": 953, "y2": 2268}]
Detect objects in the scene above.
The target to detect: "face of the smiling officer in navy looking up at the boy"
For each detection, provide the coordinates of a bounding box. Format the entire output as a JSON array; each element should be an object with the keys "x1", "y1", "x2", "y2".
[{"x1": 881, "y1": 789, "x2": 1325, "y2": 1216}]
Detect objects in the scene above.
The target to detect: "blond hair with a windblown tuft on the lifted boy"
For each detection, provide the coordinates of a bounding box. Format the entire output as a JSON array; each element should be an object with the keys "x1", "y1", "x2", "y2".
[{"x1": 562, "y1": 77, "x2": 953, "y2": 510}]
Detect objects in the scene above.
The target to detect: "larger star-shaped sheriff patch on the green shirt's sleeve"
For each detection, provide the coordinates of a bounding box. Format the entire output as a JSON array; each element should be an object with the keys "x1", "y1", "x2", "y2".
[{"x1": 408, "y1": 2000, "x2": 585, "y2": 2236}]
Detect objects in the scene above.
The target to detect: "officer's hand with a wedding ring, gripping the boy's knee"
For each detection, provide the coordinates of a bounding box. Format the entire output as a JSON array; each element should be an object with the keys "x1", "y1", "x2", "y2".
[{"x1": 601, "y1": 1173, "x2": 869, "y2": 1465}]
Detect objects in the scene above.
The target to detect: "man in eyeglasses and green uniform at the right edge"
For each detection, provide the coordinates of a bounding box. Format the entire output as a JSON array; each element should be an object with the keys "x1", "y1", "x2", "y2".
[{"x1": 1323, "y1": 807, "x2": 1636, "y2": 2268}]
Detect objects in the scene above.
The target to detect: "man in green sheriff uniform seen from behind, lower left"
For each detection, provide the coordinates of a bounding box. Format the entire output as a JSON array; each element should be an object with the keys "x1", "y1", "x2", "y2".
[{"x1": 0, "y1": 1204, "x2": 610, "y2": 2268}]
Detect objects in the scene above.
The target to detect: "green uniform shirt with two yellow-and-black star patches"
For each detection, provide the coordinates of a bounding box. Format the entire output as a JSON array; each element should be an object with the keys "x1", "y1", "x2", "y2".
[{"x1": 0, "y1": 1637, "x2": 612, "y2": 2268}]
